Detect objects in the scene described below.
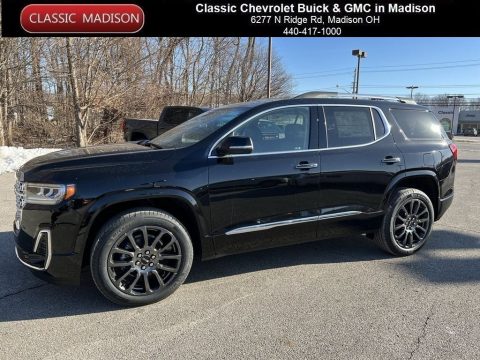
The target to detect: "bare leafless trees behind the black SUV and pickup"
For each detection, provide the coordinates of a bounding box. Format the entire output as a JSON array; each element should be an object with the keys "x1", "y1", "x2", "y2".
[{"x1": 0, "y1": 37, "x2": 292, "y2": 147}]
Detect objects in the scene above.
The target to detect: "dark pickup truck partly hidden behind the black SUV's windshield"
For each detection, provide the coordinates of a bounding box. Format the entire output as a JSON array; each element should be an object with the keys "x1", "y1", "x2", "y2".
[{"x1": 122, "y1": 106, "x2": 209, "y2": 141}]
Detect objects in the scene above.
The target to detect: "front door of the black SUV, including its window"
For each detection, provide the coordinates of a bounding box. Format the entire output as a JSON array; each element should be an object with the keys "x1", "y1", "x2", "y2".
[{"x1": 209, "y1": 106, "x2": 320, "y2": 255}]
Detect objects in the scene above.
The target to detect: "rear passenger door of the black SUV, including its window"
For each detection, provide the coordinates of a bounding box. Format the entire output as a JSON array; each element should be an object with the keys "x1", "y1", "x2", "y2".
[{"x1": 318, "y1": 105, "x2": 405, "y2": 238}]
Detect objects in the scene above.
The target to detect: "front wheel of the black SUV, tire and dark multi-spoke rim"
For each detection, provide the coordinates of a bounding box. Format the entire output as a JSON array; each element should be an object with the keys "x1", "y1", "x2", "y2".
[{"x1": 90, "y1": 208, "x2": 193, "y2": 306}]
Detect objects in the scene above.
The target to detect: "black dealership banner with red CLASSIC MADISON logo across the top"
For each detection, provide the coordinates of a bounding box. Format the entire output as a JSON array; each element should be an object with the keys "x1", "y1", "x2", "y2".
[{"x1": 2, "y1": 0, "x2": 480, "y2": 37}]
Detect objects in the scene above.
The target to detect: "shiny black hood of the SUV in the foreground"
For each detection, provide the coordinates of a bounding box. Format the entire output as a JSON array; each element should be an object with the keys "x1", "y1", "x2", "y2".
[{"x1": 18, "y1": 143, "x2": 171, "y2": 177}]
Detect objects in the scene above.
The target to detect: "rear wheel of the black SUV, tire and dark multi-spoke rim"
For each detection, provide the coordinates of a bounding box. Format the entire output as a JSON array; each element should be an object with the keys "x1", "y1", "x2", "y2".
[{"x1": 373, "y1": 188, "x2": 434, "y2": 256}]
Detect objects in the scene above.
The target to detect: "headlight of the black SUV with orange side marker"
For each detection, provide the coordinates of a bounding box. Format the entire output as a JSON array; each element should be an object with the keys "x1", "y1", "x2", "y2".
[{"x1": 25, "y1": 183, "x2": 75, "y2": 205}]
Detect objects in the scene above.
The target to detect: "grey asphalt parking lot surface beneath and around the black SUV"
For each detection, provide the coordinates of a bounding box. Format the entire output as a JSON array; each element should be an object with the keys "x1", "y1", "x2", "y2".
[{"x1": 0, "y1": 138, "x2": 480, "y2": 359}]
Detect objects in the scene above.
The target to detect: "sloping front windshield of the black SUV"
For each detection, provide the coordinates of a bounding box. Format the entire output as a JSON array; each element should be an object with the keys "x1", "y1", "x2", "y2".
[{"x1": 151, "y1": 106, "x2": 250, "y2": 149}]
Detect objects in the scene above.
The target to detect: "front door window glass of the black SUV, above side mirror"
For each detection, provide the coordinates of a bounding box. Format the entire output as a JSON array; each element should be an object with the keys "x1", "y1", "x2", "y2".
[{"x1": 233, "y1": 107, "x2": 310, "y2": 154}]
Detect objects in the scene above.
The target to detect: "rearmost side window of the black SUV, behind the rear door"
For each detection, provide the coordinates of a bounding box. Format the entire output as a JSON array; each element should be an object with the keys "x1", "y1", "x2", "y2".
[{"x1": 391, "y1": 109, "x2": 443, "y2": 140}]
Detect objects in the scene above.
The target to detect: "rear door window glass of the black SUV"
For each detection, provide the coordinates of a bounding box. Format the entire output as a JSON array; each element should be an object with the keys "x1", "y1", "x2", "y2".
[{"x1": 325, "y1": 106, "x2": 375, "y2": 147}]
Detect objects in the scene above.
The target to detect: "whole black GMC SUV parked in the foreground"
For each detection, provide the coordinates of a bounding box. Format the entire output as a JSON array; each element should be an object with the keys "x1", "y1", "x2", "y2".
[{"x1": 14, "y1": 93, "x2": 457, "y2": 306}]
